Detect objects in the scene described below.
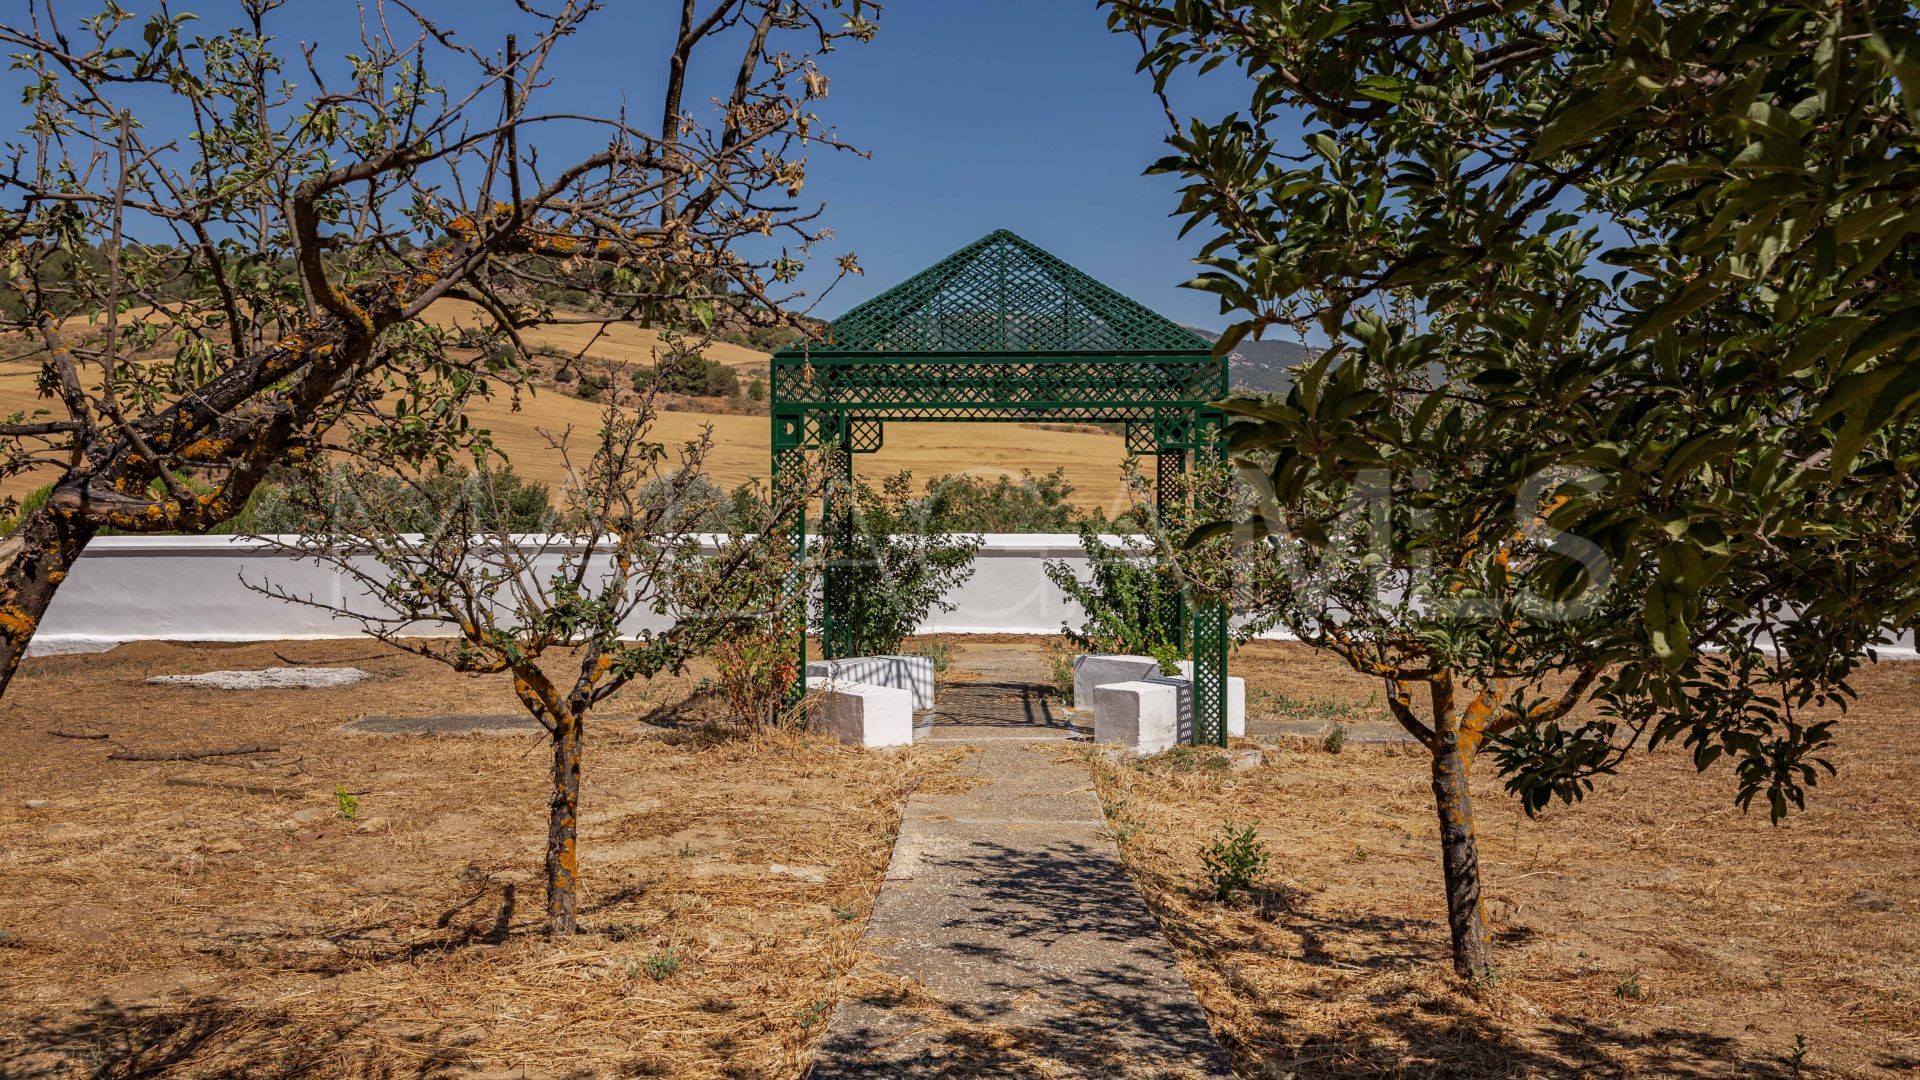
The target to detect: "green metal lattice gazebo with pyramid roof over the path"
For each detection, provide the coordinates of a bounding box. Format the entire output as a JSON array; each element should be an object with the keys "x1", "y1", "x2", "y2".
[{"x1": 772, "y1": 229, "x2": 1227, "y2": 746}]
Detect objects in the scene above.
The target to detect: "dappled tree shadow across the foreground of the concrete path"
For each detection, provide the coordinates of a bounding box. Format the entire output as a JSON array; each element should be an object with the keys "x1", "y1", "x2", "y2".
[{"x1": 812, "y1": 840, "x2": 1231, "y2": 1080}]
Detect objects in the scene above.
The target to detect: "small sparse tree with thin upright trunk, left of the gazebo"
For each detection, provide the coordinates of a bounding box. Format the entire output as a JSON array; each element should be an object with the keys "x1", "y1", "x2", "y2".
[{"x1": 250, "y1": 382, "x2": 816, "y2": 936}]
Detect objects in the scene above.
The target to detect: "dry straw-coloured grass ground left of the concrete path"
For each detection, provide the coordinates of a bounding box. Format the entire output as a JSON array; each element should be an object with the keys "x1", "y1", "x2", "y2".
[{"x1": 0, "y1": 640, "x2": 960, "y2": 1078}]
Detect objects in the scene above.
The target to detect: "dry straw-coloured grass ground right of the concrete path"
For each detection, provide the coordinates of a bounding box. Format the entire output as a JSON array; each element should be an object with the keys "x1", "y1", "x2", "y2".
[{"x1": 1098, "y1": 644, "x2": 1920, "y2": 1080}]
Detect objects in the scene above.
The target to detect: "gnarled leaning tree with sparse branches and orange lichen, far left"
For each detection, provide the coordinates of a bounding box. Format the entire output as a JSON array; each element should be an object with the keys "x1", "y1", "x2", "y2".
[{"x1": 0, "y1": 0, "x2": 874, "y2": 690}]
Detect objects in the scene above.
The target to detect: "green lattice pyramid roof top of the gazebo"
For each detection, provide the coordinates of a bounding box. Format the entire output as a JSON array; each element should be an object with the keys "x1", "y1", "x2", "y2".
[{"x1": 794, "y1": 229, "x2": 1213, "y2": 356}]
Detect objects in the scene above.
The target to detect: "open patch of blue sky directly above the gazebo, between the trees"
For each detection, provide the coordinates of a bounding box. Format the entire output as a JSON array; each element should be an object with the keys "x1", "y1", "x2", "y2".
[{"x1": 756, "y1": 0, "x2": 1244, "y2": 329}]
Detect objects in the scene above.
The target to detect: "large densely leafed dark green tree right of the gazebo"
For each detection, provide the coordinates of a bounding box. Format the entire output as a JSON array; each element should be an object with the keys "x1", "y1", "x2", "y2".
[{"x1": 1108, "y1": 0, "x2": 1920, "y2": 974}]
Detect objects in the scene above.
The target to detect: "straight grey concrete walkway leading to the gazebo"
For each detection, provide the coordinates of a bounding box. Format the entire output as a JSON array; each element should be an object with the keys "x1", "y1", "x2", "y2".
[{"x1": 812, "y1": 661, "x2": 1233, "y2": 1080}]
